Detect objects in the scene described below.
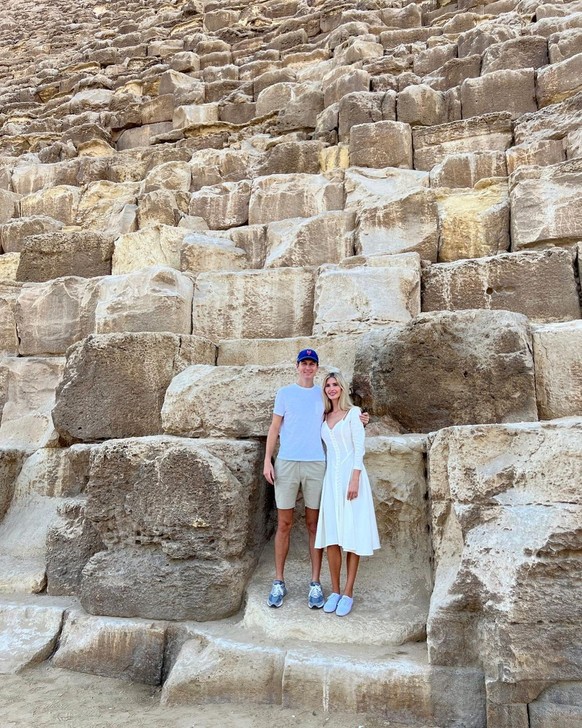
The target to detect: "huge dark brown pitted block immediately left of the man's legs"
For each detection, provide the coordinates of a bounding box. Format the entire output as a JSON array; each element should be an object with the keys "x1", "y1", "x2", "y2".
[{"x1": 81, "y1": 437, "x2": 268, "y2": 621}]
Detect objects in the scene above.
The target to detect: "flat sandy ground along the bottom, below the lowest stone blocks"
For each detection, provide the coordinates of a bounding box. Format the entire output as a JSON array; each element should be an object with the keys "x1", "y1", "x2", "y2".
[{"x1": 0, "y1": 665, "x2": 408, "y2": 728}]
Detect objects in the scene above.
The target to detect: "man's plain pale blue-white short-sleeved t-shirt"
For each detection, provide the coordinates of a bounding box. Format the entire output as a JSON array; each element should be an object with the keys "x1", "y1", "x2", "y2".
[{"x1": 273, "y1": 384, "x2": 325, "y2": 462}]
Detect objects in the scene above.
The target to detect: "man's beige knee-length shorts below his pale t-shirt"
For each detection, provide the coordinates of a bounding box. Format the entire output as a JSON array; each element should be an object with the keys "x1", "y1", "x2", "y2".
[{"x1": 275, "y1": 458, "x2": 325, "y2": 510}]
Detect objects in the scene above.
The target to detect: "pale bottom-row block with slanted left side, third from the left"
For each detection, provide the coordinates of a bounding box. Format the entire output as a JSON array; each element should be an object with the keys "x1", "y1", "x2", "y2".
[{"x1": 161, "y1": 630, "x2": 285, "y2": 705}]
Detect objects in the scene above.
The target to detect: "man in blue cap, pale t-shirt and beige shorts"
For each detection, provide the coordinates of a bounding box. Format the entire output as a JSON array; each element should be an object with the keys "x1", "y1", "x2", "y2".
[{"x1": 263, "y1": 349, "x2": 369, "y2": 609}]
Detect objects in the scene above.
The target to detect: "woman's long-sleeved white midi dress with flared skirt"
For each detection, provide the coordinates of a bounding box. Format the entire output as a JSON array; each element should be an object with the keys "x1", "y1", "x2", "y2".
[{"x1": 315, "y1": 407, "x2": 380, "y2": 556}]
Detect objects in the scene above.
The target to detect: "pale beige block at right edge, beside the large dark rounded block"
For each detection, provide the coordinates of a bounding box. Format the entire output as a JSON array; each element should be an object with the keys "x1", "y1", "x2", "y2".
[{"x1": 533, "y1": 317, "x2": 582, "y2": 420}]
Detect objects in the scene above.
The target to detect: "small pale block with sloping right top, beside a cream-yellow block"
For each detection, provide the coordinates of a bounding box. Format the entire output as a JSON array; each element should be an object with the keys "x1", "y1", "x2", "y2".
[{"x1": 180, "y1": 233, "x2": 251, "y2": 274}]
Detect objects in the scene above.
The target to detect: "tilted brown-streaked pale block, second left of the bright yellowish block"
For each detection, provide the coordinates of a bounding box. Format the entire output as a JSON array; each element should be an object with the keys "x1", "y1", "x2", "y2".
[{"x1": 265, "y1": 211, "x2": 354, "y2": 268}]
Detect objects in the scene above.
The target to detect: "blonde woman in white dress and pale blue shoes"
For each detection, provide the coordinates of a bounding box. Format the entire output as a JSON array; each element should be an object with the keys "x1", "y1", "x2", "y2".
[{"x1": 315, "y1": 372, "x2": 380, "y2": 617}]
